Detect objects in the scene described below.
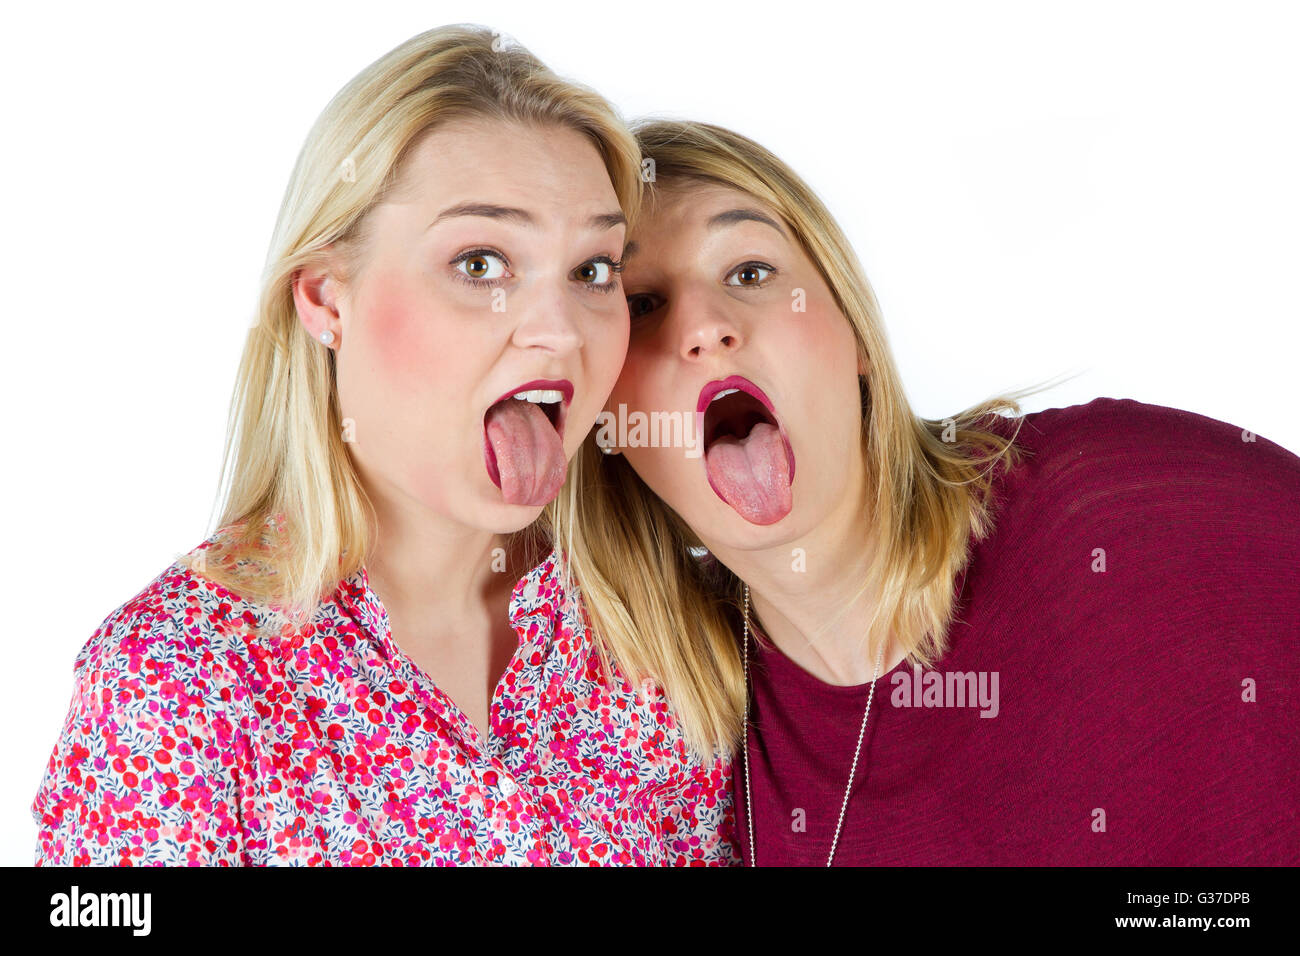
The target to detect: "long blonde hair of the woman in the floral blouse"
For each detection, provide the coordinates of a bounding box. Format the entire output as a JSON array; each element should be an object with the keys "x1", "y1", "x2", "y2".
[{"x1": 186, "y1": 25, "x2": 642, "y2": 619}]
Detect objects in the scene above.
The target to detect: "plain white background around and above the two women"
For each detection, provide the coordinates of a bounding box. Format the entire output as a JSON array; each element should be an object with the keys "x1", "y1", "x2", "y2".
[{"x1": 0, "y1": 0, "x2": 1300, "y2": 865}]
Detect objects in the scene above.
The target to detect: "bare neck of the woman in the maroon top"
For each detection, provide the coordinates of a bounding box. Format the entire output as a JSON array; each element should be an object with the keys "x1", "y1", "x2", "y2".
[{"x1": 705, "y1": 460, "x2": 904, "y2": 687}]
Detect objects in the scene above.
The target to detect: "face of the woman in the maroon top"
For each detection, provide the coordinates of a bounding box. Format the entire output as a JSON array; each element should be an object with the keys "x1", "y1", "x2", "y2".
[{"x1": 606, "y1": 183, "x2": 863, "y2": 549}]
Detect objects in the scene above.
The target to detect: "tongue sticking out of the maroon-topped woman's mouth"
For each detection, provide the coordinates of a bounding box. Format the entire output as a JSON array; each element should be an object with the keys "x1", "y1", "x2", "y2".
[{"x1": 705, "y1": 421, "x2": 793, "y2": 524}]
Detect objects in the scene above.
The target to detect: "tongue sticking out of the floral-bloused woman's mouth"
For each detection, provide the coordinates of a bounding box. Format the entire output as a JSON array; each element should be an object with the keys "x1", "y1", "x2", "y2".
[{"x1": 484, "y1": 398, "x2": 566, "y2": 506}]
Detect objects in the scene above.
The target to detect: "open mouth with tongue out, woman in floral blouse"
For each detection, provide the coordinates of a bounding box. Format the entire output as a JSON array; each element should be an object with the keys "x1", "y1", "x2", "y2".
[{"x1": 484, "y1": 378, "x2": 573, "y2": 506}]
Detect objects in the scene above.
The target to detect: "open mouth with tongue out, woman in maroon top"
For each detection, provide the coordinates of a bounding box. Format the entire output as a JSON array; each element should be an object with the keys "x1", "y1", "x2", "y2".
[{"x1": 697, "y1": 375, "x2": 794, "y2": 524}]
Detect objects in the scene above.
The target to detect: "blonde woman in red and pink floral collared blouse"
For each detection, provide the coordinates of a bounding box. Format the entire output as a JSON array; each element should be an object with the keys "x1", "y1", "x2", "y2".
[{"x1": 33, "y1": 27, "x2": 736, "y2": 865}]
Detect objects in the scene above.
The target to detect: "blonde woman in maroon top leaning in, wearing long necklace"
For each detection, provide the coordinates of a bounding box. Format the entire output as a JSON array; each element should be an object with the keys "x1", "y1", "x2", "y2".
[{"x1": 555, "y1": 121, "x2": 1300, "y2": 865}]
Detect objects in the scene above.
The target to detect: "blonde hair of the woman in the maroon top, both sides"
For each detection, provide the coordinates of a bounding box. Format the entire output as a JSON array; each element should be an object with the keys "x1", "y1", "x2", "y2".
[{"x1": 550, "y1": 120, "x2": 1035, "y2": 754}]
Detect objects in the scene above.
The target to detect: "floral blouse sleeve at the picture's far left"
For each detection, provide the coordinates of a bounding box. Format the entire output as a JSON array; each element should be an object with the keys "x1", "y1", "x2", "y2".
[{"x1": 31, "y1": 601, "x2": 251, "y2": 866}]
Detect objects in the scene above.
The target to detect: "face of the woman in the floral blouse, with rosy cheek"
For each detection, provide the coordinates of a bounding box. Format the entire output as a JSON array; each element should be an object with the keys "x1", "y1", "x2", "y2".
[{"x1": 304, "y1": 121, "x2": 628, "y2": 532}]
